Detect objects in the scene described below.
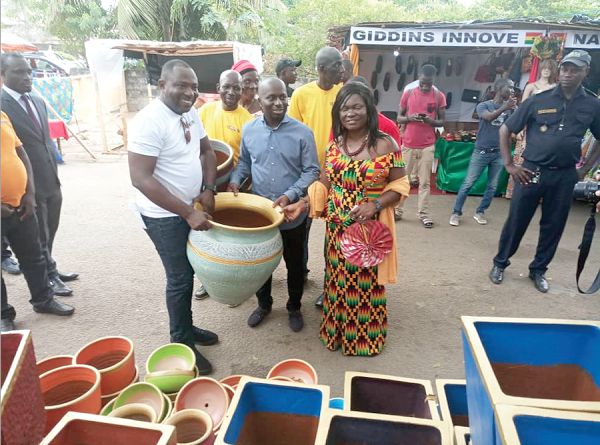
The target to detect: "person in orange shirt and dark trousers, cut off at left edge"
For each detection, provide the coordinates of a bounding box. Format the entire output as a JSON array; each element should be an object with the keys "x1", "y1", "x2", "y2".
[{"x1": 0, "y1": 111, "x2": 74, "y2": 332}]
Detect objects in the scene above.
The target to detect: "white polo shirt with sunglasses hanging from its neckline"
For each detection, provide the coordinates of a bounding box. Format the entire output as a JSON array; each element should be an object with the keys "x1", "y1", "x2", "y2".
[{"x1": 128, "y1": 99, "x2": 206, "y2": 218}]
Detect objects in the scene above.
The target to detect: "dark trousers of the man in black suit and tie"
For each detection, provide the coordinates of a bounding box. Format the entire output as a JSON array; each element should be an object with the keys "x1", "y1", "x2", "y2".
[{"x1": 35, "y1": 189, "x2": 62, "y2": 279}]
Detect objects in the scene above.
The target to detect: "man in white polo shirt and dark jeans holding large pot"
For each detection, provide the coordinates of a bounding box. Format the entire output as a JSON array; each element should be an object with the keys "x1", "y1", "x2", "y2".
[{"x1": 128, "y1": 60, "x2": 219, "y2": 374}]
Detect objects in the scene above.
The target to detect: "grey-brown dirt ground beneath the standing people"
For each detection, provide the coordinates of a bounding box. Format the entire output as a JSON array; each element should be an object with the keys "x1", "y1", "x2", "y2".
[{"x1": 5, "y1": 142, "x2": 600, "y2": 396}]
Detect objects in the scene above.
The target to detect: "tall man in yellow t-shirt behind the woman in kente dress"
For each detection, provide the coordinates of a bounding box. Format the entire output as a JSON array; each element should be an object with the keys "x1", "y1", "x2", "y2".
[{"x1": 288, "y1": 46, "x2": 344, "y2": 307}]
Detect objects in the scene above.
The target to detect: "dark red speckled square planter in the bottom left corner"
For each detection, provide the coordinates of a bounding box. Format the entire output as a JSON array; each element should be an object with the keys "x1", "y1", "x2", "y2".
[{"x1": 0, "y1": 331, "x2": 46, "y2": 445}]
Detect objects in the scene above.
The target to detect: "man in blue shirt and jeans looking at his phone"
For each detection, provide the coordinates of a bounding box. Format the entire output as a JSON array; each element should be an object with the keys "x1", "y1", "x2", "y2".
[{"x1": 450, "y1": 79, "x2": 517, "y2": 226}]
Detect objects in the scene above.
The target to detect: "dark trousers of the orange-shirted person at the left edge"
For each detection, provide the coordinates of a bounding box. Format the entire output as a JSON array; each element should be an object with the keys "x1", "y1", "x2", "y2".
[{"x1": 2, "y1": 213, "x2": 54, "y2": 320}]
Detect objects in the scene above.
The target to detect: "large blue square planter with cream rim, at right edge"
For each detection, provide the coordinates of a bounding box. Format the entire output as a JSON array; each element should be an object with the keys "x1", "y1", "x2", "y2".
[{"x1": 462, "y1": 317, "x2": 600, "y2": 445}]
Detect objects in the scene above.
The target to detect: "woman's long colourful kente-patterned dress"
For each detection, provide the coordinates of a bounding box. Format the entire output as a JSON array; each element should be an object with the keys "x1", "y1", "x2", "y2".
[{"x1": 320, "y1": 142, "x2": 404, "y2": 356}]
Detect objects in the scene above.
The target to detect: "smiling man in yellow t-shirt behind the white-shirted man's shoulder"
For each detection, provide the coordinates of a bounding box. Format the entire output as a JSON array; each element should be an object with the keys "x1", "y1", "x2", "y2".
[{"x1": 198, "y1": 70, "x2": 254, "y2": 166}]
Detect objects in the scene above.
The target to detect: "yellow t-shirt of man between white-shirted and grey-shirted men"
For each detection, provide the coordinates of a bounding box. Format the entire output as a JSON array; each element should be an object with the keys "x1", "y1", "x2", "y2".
[{"x1": 198, "y1": 100, "x2": 254, "y2": 165}]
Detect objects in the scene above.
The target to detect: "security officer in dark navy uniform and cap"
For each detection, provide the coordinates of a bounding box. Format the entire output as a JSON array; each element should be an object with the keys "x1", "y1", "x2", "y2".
[{"x1": 489, "y1": 50, "x2": 600, "y2": 292}]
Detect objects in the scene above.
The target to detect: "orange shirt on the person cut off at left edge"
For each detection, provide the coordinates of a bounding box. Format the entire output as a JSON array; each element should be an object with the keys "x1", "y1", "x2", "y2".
[{"x1": 0, "y1": 111, "x2": 27, "y2": 207}]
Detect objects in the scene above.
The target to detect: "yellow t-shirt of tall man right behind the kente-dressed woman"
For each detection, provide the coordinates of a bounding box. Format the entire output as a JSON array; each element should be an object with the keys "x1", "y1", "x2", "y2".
[{"x1": 288, "y1": 81, "x2": 342, "y2": 166}]
